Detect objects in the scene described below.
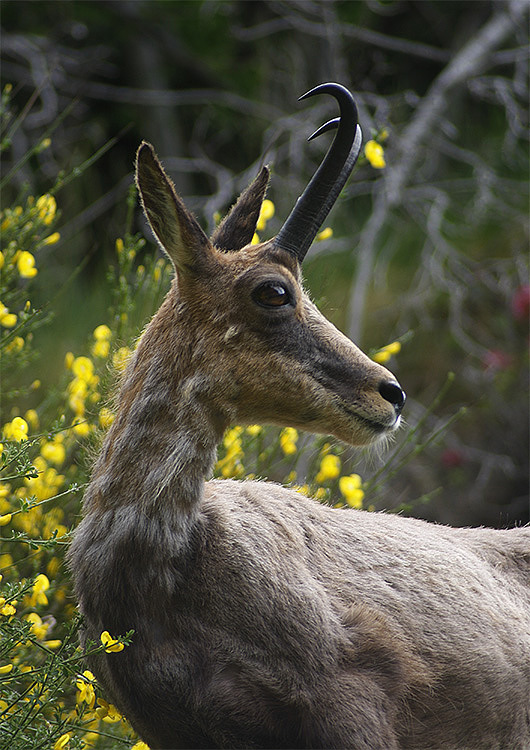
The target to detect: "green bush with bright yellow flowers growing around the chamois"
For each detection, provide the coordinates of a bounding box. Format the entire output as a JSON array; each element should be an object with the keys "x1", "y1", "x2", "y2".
[{"x1": 0, "y1": 88, "x2": 442, "y2": 750}]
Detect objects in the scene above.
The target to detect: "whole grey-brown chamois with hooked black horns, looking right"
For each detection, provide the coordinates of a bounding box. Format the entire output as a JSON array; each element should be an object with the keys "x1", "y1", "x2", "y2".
[{"x1": 69, "y1": 83, "x2": 530, "y2": 750}]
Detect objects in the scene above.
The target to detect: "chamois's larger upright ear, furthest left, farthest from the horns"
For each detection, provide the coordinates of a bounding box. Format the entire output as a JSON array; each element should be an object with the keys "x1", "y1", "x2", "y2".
[{"x1": 136, "y1": 141, "x2": 210, "y2": 272}]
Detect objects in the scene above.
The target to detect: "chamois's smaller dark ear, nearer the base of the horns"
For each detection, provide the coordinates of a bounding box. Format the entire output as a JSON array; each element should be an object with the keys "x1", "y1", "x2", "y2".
[{"x1": 211, "y1": 167, "x2": 269, "y2": 252}]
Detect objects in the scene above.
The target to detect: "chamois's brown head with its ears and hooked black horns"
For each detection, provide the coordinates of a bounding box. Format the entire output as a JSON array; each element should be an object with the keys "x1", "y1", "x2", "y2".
[{"x1": 137, "y1": 83, "x2": 405, "y2": 445}]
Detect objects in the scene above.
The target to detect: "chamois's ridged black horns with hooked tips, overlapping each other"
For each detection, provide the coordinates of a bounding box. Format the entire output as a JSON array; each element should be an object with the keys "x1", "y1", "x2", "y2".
[{"x1": 274, "y1": 83, "x2": 362, "y2": 262}]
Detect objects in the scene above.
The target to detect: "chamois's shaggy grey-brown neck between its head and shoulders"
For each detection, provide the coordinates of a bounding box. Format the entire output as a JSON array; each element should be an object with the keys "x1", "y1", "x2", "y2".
[{"x1": 85, "y1": 296, "x2": 226, "y2": 520}]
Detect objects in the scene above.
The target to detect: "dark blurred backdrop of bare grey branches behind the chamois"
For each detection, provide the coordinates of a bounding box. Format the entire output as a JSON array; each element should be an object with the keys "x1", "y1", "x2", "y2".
[{"x1": 1, "y1": 0, "x2": 530, "y2": 527}]
